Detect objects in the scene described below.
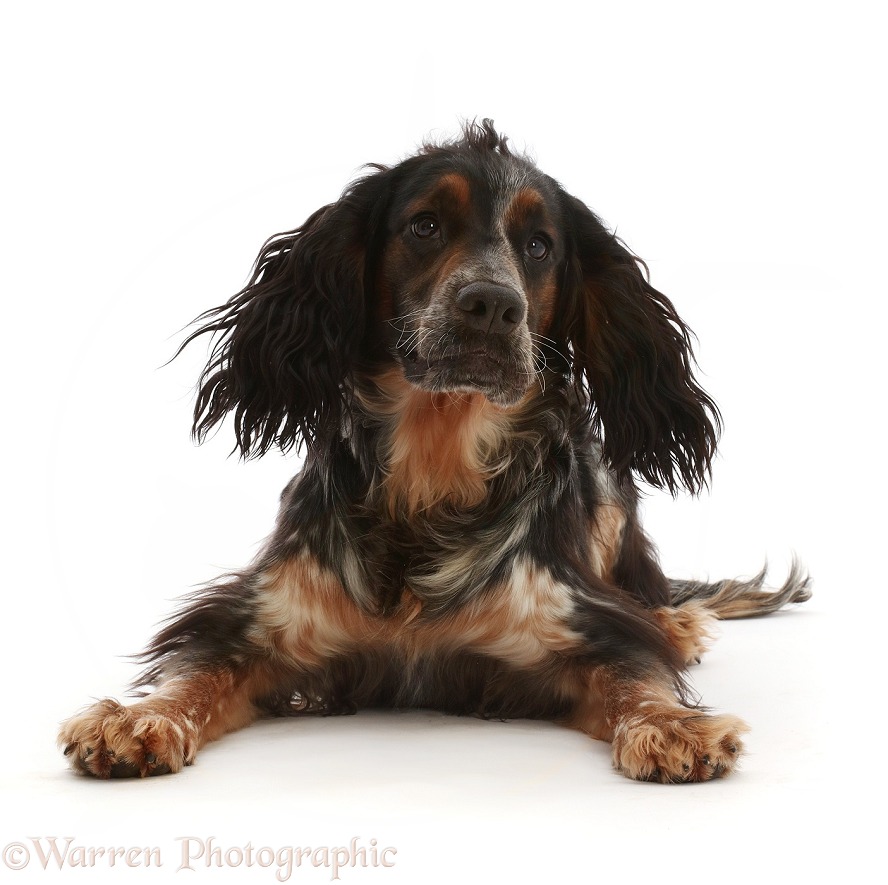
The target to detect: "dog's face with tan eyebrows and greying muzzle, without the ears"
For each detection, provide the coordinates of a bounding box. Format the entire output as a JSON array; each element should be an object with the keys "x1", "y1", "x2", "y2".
[{"x1": 377, "y1": 157, "x2": 565, "y2": 405}]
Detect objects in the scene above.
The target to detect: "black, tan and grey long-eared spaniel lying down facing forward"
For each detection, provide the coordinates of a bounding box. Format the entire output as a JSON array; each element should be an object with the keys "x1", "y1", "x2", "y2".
[{"x1": 60, "y1": 119, "x2": 810, "y2": 783}]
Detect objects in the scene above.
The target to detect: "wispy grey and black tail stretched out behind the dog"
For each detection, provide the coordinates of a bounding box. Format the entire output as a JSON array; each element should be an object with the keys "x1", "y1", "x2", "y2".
[{"x1": 669, "y1": 559, "x2": 811, "y2": 620}]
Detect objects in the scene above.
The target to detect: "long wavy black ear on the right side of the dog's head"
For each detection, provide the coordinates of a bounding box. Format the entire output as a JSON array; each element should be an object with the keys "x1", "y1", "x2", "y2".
[{"x1": 562, "y1": 195, "x2": 721, "y2": 495}]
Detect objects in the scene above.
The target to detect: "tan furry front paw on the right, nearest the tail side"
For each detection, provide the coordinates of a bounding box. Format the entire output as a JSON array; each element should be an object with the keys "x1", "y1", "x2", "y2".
[{"x1": 613, "y1": 707, "x2": 749, "y2": 784}]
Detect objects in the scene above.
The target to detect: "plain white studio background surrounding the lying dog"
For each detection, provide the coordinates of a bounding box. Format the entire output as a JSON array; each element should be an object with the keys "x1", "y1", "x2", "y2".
[{"x1": 0, "y1": 0, "x2": 888, "y2": 883}]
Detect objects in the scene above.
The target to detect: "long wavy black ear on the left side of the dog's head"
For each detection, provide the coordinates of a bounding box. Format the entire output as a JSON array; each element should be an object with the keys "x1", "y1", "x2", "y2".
[{"x1": 179, "y1": 167, "x2": 388, "y2": 457}]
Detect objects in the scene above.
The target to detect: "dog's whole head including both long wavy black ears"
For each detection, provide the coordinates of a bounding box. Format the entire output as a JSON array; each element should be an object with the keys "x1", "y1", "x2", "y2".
[{"x1": 186, "y1": 120, "x2": 719, "y2": 491}]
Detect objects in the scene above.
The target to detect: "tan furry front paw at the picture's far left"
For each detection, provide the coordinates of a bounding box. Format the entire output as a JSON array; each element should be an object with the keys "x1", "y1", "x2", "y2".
[{"x1": 59, "y1": 699, "x2": 197, "y2": 778}]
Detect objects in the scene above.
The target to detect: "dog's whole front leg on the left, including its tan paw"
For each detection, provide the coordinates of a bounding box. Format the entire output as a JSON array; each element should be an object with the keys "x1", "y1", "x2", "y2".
[{"x1": 59, "y1": 552, "x2": 360, "y2": 778}]
